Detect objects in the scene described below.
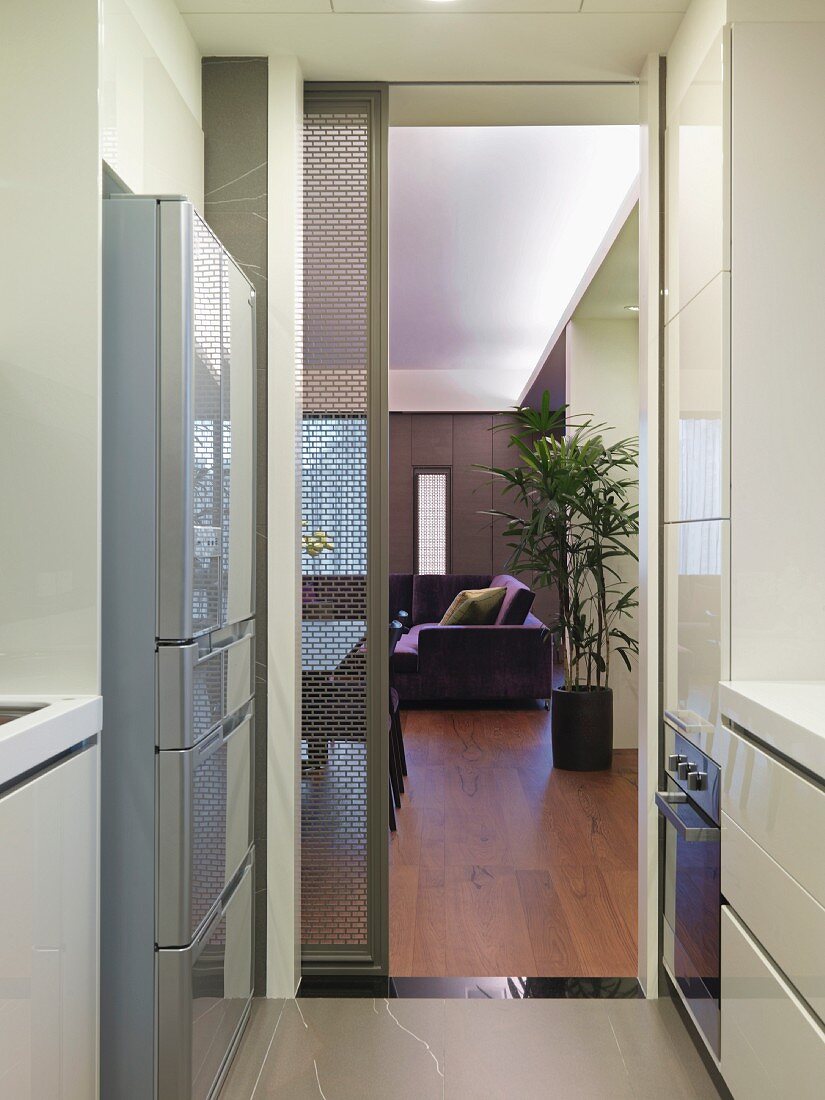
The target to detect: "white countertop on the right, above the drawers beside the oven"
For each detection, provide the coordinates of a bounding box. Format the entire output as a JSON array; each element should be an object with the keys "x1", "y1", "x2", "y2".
[{"x1": 719, "y1": 680, "x2": 825, "y2": 782}]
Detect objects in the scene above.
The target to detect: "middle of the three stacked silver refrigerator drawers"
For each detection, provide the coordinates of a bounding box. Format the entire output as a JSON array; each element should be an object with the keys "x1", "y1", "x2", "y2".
[{"x1": 155, "y1": 704, "x2": 254, "y2": 947}]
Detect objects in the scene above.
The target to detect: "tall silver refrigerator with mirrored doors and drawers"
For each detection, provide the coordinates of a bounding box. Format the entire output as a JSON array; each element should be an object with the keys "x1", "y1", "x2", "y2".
[{"x1": 101, "y1": 195, "x2": 255, "y2": 1100}]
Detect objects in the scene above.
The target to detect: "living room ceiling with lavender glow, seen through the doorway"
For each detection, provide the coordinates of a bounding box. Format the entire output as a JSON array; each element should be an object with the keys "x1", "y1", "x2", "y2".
[{"x1": 389, "y1": 127, "x2": 639, "y2": 411}]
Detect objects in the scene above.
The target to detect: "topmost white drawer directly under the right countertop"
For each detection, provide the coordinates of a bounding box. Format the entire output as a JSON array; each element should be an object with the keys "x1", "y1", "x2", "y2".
[{"x1": 717, "y1": 717, "x2": 825, "y2": 905}]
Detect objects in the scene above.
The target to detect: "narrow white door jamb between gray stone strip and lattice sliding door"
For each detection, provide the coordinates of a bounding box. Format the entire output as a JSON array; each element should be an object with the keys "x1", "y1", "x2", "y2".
[{"x1": 266, "y1": 57, "x2": 304, "y2": 997}]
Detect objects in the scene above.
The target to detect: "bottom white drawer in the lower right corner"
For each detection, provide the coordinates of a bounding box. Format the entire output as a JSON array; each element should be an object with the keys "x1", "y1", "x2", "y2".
[{"x1": 722, "y1": 905, "x2": 825, "y2": 1100}]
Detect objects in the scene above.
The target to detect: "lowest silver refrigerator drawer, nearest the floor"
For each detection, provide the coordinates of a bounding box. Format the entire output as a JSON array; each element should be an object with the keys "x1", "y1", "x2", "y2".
[{"x1": 156, "y1": 851, "x2": 254, "y2": 1100}]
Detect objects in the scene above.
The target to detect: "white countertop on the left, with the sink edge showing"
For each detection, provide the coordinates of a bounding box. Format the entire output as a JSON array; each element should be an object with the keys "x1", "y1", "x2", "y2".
[{"x1": 0, "y1": 695, "x2": 102, "y2": 789}]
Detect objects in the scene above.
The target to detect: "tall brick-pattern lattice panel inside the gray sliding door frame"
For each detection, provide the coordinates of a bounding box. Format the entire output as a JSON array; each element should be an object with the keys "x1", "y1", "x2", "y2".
[{"x1": 301, "y1": 108, "x2": 371, "y2": 955}]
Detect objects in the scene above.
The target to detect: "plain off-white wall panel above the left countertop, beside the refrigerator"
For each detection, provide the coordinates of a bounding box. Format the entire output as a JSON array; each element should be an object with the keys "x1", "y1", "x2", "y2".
[{"x1": 0, "y1": 0, "x2": 100, "y2": 694}]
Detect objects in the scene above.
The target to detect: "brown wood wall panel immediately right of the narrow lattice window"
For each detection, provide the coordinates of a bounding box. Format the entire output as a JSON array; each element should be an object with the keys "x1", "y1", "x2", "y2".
[{"x1": 451, "y1": 413, "x2": 493, "y2": 573}]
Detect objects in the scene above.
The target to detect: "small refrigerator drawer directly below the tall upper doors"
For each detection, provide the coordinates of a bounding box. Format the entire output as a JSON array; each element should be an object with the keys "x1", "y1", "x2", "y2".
[{"x1": 157, "y1": 619, "x2": 255, "y2": 749}]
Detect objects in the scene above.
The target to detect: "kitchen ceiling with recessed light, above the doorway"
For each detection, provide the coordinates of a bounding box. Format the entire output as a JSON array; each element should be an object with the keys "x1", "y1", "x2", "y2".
[{"x1": 178, "y1": 0, "x2": 688, "y2": 81}]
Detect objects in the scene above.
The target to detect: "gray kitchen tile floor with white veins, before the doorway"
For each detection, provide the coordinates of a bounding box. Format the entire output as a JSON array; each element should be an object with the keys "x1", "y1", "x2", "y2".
[{"x1": 219, "y1": 998, "x2": 718, "y2": 1100}]
